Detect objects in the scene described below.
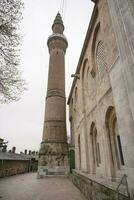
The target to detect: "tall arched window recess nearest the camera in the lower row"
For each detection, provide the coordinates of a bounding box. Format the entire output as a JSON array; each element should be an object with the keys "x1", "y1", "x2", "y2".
[{"x1": 106, "y1": 106, "x2": 124, "y2": 177}]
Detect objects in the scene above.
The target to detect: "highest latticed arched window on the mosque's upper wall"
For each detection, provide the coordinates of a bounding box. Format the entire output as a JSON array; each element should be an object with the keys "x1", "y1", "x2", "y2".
[{"x1": 96, "y1": 41, "x2": 107, "y2": 80}]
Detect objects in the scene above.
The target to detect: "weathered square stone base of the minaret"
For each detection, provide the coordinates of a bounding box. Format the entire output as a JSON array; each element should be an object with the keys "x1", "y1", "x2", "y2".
[{"x1": 37, "y1": 141, "x2": 69, "y2": 178}]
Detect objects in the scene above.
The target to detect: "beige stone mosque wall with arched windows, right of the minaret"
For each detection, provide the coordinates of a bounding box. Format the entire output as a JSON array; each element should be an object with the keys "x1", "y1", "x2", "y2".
[{"x1": 68, "y1": 0, "x2": 134, "y2": 198}]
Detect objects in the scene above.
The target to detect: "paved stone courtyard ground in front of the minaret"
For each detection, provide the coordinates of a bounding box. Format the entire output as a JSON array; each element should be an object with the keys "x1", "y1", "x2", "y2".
[{"x1": 0, "y1": 173, "x2": 85, "y2": 200}]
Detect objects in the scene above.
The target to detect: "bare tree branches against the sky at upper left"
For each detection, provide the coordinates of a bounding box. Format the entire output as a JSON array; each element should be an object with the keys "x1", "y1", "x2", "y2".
[{"x1": 0, "y1": 0, "x2": 25, "y2": 103}]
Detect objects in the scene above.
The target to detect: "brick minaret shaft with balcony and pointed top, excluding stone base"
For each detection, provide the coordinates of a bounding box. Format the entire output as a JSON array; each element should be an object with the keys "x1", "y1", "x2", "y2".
[{"x1": 43, "y1": 13, "x2": 67, "y2": 142}]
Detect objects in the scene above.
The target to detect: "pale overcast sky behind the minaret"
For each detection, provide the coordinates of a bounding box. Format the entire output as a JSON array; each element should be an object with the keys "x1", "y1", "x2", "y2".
[{"x1": 0, "y1": 0, "x2": 94, "y2": 152}]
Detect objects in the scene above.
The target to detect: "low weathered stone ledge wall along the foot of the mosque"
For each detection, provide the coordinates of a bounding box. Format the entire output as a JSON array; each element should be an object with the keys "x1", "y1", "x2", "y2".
[{"x1": 70, "y1": 170, "x2": 129, "y2": 200}]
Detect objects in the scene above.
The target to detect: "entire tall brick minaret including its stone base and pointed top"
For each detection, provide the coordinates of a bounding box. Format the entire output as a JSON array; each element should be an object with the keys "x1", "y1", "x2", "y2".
[{"x1": 38, "y1": 13, "x2": 68, "y2": 177}]
